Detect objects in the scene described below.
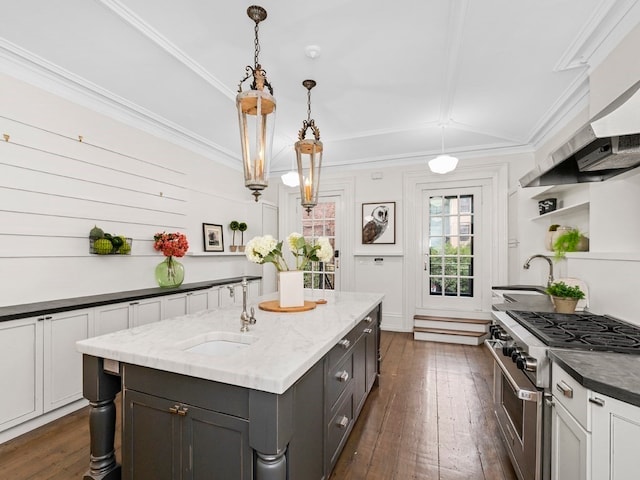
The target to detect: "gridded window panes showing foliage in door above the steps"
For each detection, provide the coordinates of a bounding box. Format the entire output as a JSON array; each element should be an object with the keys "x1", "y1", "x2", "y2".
[{"x1": 429, "y1": 195, "x2": 474, "y2": 297}]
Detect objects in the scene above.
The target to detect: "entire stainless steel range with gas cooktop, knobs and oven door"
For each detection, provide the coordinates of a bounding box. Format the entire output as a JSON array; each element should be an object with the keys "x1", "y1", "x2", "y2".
[{"x1": 485, "y1": 311, "x2": 640, "y2": 480}]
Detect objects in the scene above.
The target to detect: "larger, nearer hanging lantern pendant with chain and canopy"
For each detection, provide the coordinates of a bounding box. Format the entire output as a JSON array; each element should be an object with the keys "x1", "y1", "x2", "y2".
[{"x1": 236, "y1": 5, "x2": 276, "y2": 202}]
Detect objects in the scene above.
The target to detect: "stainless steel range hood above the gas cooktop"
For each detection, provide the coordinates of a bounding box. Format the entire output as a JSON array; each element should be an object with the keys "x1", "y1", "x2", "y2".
[{"x1": 520, "y1": 82, "x2": 640, "y2": 187}]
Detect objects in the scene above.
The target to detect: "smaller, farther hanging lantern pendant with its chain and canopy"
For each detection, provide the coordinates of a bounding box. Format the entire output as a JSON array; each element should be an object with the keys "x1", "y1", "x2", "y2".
[{"x1": 295, "y1": 80, "x2": 323, "y2": 213}]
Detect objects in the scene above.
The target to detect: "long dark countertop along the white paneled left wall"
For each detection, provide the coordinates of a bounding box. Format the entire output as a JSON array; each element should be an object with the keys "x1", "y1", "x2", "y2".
[{"x1": 0, "y1": 276, "x2": 262, "y2": 322}]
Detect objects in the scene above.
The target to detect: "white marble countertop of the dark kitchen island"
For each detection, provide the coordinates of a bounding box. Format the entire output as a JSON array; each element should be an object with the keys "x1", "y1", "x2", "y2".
[{"x1": 76, "y1": 292, "x2": 383, "y2": 394}]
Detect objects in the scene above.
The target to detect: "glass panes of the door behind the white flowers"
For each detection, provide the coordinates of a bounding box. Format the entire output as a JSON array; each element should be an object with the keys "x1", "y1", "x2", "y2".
[{"x1": 302, "y1": 197, "x2": 337, "y2": 290}]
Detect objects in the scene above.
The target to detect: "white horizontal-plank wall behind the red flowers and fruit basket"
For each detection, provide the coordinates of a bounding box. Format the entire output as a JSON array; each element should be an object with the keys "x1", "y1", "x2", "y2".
[{"x1": 0, "y1": 76, "x2": 262, "y2": 306}]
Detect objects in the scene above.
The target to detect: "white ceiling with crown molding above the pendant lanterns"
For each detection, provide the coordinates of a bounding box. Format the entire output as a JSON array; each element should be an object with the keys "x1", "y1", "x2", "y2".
[{"x1": 0, "y1": 0, "x2": 640, "y2": 171}]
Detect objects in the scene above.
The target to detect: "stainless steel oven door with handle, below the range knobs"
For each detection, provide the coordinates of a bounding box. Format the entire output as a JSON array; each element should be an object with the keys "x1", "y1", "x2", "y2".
[{"x1": 485, "y1": 340, "x2": 544, "y2": 480}]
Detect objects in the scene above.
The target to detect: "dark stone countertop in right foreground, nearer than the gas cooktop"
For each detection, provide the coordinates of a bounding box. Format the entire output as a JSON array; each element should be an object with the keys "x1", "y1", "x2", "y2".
[{"x1": 549, "y1": 348, "x2": 640, "y2": 407}]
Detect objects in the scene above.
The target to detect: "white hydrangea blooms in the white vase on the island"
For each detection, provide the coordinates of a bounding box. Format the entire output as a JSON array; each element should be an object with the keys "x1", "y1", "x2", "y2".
[{"x1": 245, "y1": 232, "x2": 333, "y2": 272}]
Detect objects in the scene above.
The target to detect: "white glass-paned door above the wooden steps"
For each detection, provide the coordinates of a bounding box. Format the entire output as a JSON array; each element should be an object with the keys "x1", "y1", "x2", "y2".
[{"x1": 421, "y1": 187, "x2": 481, "y2": 310}]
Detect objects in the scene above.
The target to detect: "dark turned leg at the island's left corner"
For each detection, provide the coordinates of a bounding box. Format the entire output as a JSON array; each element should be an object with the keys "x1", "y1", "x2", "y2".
[{"x1": 83, "y1": 355, "x2": 121, "y2": 480}]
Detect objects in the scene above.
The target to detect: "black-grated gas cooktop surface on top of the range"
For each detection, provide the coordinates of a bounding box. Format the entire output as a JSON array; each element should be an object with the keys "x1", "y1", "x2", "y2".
[{"x1": 507, "y1": 310, "x2": 640, "y2": 354}]
